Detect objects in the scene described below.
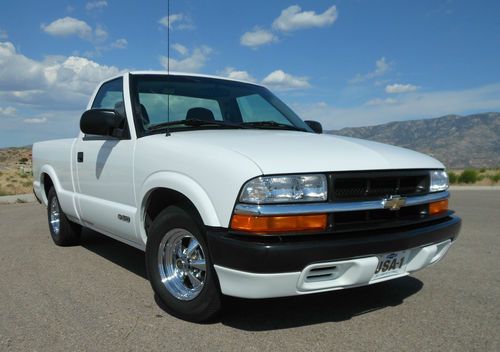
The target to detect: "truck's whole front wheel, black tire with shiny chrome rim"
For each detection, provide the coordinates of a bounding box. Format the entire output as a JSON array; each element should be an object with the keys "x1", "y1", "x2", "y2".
[{"x1": 146, "y1": 206, "x2": 221, "y2": 322}]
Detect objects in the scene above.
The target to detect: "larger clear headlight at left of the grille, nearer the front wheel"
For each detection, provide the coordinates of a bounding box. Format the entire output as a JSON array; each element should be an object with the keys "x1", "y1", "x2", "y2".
[{"x1": 240, "y1": 174, "x2": 328, "y2": 204}]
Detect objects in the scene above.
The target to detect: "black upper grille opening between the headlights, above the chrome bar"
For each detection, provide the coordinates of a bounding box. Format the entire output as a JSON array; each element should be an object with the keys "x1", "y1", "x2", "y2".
[{"x1": 331, "y1": 170, "x2": 429, "y2": 201}]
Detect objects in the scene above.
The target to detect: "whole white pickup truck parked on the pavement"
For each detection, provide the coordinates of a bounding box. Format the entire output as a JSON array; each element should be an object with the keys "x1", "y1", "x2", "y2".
[{"x1": 33, "y1": 72, "x2": 461, "y2": 321}]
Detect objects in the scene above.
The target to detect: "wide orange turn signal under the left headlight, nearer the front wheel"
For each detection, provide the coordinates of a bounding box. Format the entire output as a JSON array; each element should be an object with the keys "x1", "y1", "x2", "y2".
[{"x1": 231, "y1": 214, "x2": 327, "y2": 233}]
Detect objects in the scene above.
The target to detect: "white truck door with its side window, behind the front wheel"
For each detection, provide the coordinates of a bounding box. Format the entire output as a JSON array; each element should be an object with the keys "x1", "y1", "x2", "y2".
[{"x1": 73, "y1": 77, "x2": 136, "y2": 242}]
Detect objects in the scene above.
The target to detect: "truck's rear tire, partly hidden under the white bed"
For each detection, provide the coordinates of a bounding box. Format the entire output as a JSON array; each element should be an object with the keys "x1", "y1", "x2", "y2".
[{"x1": 47, "y1": 187, "x2": 82, "y2": 246}]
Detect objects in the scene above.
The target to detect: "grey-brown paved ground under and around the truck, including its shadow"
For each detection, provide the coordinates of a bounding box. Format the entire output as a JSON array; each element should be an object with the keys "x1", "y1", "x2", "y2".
[{"x1": 0, "y1": 191, "x2": 500, "y2": 351}]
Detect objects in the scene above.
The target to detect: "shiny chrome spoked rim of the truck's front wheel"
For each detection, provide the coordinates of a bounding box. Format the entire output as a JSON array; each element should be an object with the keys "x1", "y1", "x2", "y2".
[{"x1": 158, "y1": 229, "x2": 207, "y2": 301}]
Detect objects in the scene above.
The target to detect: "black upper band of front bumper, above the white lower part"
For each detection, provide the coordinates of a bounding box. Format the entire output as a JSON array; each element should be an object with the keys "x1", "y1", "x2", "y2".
[{"x1": 207, "y1": 216, "x2": 461, "y2": 273}]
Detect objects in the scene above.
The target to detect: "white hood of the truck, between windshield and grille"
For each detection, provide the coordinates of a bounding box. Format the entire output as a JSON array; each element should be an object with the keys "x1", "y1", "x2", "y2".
[{"x1": 157, "y1": 130, "x2": 444, "y2": 174}]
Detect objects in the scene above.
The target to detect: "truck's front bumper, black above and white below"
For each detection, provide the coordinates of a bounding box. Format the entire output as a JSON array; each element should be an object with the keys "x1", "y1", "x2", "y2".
[{"x1": 207, "y1": 216, "x2": 461, "y2": 298}]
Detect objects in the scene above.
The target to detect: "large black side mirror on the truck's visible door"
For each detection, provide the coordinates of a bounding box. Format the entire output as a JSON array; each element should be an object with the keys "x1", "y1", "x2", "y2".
[{"x1": 80, "y1": 109, "x2": 125, "y2": 138}]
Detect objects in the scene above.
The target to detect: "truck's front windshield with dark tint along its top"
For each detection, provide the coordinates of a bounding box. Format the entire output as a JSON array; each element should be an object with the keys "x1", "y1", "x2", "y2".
[{"x1": 130, "y1": 75, "x2": 312, "y2": 136}]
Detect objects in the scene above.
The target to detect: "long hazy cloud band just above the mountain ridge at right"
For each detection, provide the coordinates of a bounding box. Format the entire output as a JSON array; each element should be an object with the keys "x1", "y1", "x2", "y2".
[{"x1": 293, "y1": 83, "x2": 500, "y2": 129}]
